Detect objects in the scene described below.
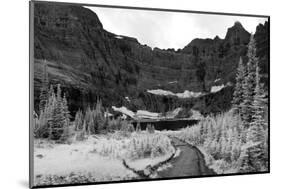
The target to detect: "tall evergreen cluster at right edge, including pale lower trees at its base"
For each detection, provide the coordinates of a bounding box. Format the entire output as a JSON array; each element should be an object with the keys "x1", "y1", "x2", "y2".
[{"x1": 232, "y1": 36, "x2": 268, "y2": 172}]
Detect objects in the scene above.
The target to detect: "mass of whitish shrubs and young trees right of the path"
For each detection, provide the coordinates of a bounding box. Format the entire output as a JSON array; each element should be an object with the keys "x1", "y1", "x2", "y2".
[{"x1": 174, "y1": 112, "x2": 266, "y2": 174}]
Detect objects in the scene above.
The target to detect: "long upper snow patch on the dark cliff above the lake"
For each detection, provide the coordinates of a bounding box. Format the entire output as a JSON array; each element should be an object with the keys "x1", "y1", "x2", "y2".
[{"x1": 147, "y1": 89, "x2": 203, "y2": 98}]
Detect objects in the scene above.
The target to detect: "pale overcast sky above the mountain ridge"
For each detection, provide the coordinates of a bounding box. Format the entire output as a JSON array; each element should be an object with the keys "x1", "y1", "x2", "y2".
[{"x1": 86, "y1": 7, "x2": 267, "y2": 49}]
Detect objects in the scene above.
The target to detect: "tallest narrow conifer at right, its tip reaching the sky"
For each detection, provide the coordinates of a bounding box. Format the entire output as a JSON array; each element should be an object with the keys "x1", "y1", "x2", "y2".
[{"x1": 242, "y1": 35, "x2": 258, "y2": 128}]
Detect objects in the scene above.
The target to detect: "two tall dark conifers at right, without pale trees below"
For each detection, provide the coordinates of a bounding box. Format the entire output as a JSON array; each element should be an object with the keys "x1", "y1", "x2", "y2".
[{"x1": 232, "y1": 36, "x2": 266, "y2": 128}]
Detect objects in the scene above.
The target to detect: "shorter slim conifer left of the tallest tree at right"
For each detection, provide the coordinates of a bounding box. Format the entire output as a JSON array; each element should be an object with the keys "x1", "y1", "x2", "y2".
[{"x1": 232, "y1": 57, "x2": 246, "y2": 114}]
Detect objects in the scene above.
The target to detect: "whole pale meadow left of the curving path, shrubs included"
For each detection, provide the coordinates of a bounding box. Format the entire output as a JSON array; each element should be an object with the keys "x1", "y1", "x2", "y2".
[{"x1": 34, "y1": 132, "x2": 173, "y2": 185}]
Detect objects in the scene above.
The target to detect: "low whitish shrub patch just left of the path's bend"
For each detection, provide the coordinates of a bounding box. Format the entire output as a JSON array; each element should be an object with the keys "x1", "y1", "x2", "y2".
[{"x1": 90, "y1": 132, "x2": 174, "y2": 160}]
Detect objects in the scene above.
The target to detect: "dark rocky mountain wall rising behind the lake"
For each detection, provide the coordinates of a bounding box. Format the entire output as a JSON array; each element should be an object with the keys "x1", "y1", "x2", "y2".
[{"x1": 34, "y1": 3, "x2": 269, "y2": 113}]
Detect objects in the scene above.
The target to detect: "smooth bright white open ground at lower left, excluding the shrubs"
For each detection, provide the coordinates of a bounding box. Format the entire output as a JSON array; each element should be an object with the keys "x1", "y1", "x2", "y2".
[{"x1": 34, "y1": 139, "x2": 137, "y2": 184}]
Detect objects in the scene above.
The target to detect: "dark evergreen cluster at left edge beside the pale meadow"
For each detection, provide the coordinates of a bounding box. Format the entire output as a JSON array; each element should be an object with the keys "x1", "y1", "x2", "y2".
[{"x1": 34, "y1": 62, "x2": 71, "y2": 142}]
